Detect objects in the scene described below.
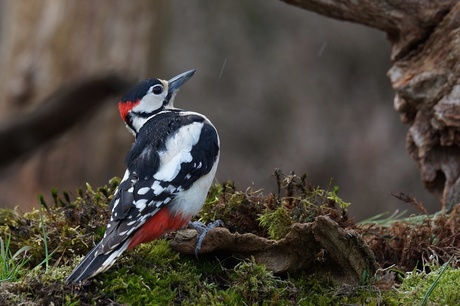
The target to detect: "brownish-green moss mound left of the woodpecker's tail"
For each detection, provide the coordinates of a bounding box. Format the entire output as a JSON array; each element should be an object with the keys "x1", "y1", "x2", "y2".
[{"x1": 0, "y1": 179, "x2": 119, "y2": 268}]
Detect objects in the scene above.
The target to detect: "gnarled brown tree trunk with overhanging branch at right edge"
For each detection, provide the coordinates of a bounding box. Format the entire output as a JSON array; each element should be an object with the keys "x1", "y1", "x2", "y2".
[{"x1": 284, "y1": 0, "x2": 460, "y2": 210}]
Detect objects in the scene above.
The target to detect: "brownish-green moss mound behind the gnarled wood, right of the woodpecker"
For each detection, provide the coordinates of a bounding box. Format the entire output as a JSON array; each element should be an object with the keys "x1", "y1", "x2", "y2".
[{"x1": 200, "y1": 170, "x2": 355, "y2": 239}]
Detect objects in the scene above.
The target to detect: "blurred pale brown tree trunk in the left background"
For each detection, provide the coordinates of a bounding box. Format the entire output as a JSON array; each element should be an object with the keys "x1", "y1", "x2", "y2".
[{"x1": 0, "y1": 0, "x2": 165, "y2": 209}]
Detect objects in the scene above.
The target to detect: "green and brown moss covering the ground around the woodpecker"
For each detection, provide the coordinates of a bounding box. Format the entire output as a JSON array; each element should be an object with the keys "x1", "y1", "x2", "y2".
[{"x1": 0, "y1": 172, "x2": 460, "y2": 305}]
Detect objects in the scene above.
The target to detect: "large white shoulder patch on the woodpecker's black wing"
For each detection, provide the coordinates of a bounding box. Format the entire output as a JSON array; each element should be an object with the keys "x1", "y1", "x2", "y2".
[{"x1": 152, "y1": 122, "x2": 204, "y2": 182}]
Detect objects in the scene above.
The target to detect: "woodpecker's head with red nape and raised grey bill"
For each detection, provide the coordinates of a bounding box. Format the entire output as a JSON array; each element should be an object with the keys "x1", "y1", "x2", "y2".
[{"x1": 118, "y1": 69, "x2": 195, "y2": 135}]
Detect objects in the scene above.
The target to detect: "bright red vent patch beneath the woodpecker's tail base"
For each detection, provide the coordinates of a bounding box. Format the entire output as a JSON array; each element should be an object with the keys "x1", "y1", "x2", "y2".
[{"x1": 128, "y1": 208, "x2": 191, "y2": 250}]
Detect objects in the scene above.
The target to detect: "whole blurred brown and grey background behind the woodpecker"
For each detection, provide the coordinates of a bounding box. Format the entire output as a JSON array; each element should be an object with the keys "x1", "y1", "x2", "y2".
[{"x1": 0, "y1": 0, "x2": 438, "y2": 220}]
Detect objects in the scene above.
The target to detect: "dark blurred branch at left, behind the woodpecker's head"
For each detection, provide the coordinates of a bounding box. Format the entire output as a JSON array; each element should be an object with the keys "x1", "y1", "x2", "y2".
[{"x1": 0, "y1": 74, "x2": 131, "y2": 166}]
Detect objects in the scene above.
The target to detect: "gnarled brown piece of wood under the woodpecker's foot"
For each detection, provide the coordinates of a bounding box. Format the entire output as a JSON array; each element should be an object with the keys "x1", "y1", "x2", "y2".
[{"x1": 171, "y1": 216, "x2": 377, "y2": 282}]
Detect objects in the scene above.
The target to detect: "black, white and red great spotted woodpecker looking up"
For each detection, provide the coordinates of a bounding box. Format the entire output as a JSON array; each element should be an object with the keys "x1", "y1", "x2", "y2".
[{"x1": 66, "y1": 70, "x2": 220, "y2": 283}]
